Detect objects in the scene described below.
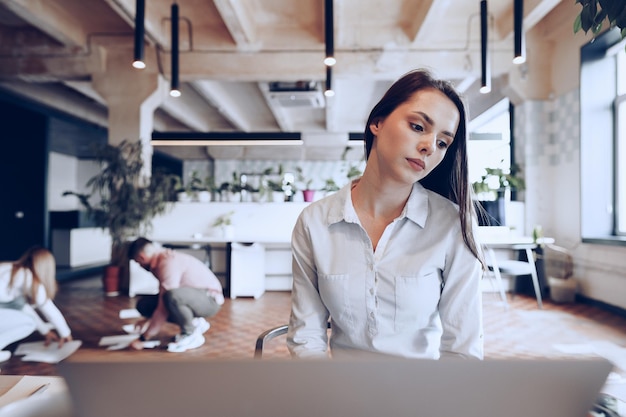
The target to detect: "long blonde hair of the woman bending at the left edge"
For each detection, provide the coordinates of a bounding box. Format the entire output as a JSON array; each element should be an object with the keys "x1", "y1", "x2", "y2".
[{"x1": 10, "y1": 246, "x2": 57, "y2": 302}]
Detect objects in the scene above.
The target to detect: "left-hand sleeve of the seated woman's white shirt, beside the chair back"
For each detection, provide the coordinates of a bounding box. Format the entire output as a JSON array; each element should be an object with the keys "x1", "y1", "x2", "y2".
[{"x1": 287, "y1": 215, "x2": 329, "y2": 358}]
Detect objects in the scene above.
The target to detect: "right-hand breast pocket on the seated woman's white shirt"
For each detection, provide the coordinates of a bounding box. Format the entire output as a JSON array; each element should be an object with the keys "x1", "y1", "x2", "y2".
[{"x1": 394, "y1": 270, "x2": 441, "y2": 332}]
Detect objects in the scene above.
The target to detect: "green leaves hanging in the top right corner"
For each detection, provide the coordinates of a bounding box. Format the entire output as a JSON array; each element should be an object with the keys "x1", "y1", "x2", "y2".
[{"x1": 574, "y1": 0, "x2": 626, "y2": 52}]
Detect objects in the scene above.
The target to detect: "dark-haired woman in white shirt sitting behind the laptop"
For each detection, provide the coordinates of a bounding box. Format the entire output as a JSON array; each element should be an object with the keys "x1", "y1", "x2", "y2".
[{"x1": 287, "y1": 70, "x2": 483, "y2": 359}]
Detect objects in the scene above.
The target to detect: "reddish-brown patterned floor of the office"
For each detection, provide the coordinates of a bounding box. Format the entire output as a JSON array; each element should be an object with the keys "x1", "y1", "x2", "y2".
[{"x1": 0, "y1": 277, "x2": 626, "y2": 375}]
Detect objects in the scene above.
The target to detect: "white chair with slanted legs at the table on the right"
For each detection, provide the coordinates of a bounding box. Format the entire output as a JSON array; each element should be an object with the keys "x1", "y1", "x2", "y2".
[{"x1": 485, "y1": 243, "x2": 543, "y2": 308}]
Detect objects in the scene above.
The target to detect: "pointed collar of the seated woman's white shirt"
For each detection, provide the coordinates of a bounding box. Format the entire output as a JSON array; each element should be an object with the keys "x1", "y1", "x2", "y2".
[{"x1": 328, "y1": 182, "x2": 428, "y2": 227}]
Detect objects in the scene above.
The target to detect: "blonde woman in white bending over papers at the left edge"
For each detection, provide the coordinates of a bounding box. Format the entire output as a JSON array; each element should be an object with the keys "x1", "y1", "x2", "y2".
[{"x1": 0, "y1": 247, "x2": 72, "y2": 362}]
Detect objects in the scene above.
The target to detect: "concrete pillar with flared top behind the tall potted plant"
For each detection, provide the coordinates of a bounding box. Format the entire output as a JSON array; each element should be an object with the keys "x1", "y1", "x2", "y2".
[{"x1": 92, "y1": 48, "x2": 167, "y2": 175}]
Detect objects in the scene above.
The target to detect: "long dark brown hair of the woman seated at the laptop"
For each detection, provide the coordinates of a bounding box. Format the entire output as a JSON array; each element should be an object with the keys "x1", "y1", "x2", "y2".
[{"x1": 364, "y1": 69, "x2": 485, "y2": 267}]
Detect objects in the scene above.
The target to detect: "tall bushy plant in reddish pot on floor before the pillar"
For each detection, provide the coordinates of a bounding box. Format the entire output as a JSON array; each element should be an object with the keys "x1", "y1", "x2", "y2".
[{"x1": 63, "y1": 140, "x2": 178, "y2": 292}]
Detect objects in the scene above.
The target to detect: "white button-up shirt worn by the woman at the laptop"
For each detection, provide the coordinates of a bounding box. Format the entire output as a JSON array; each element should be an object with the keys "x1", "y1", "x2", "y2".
[{"x1": 287, "y1": 183, "x2": 483, "y2": 359}]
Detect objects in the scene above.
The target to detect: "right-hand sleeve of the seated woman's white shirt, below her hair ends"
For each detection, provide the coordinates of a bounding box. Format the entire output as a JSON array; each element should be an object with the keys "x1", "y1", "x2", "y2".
[{"x1": 439, "y1": 224, "x2": 483, "y2": 359}]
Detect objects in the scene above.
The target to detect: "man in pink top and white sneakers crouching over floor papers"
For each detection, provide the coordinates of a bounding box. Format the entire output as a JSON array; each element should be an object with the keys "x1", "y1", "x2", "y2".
[{"x1": 128, "y1": 237, "x2": 224, "y2": 352}]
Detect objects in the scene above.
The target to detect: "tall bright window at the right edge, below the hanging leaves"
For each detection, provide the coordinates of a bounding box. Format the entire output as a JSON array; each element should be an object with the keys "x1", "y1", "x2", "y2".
[{"x1": 580, "y1": 30, "x2": 626, "y2": 245}]
